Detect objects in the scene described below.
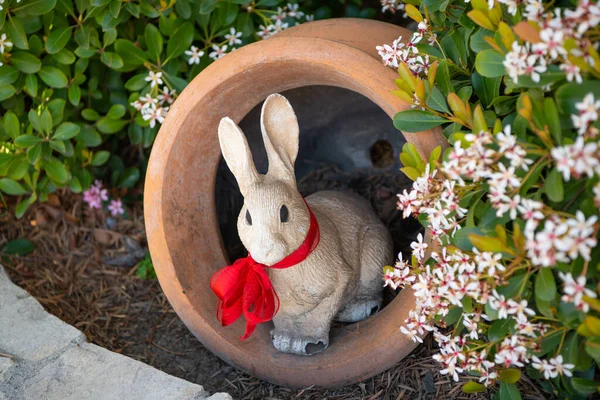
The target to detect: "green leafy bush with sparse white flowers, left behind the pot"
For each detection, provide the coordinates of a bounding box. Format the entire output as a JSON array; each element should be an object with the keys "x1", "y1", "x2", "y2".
[{"x1": 0, "y1": 0, "x2": 375, "y2": 217}]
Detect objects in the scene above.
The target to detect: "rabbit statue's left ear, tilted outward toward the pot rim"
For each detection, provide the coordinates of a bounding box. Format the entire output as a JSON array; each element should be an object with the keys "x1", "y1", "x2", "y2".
[{"x1": 219, "y1": 117, "x2": 258, "y2": 196}]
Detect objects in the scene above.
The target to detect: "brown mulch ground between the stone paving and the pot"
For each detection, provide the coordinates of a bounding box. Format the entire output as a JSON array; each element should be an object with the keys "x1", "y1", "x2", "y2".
[{"x1": 0, "y1": 177, "x2": 545, "y2": 399}]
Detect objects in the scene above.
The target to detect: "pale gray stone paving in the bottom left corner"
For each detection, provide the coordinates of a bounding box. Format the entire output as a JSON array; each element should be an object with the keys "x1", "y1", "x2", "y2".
[{"x1": 0, "y1": 266, "x2": 231, "y2": 400}]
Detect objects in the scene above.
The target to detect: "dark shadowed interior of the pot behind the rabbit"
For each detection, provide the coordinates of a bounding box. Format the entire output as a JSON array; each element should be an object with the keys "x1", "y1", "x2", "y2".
[{"x1": 215, "y1": 86, "x2": 423, "y2": 307}]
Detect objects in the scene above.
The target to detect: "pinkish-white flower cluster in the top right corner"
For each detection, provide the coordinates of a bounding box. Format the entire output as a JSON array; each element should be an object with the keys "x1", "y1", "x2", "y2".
[{"x1": 502, "y1": 0, "x2": 600, "y2": 83}]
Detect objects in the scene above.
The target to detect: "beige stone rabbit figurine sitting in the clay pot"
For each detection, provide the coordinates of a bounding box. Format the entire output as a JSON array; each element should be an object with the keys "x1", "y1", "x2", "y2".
[{"x1": 218, "y1": 94, "x2": 393, "y2": 355}]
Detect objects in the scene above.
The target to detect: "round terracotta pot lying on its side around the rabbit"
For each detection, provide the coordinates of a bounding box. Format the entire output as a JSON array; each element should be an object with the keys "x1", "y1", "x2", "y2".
[{"x1": 144, "y1": 19, "x2": 443, "y2": 387}]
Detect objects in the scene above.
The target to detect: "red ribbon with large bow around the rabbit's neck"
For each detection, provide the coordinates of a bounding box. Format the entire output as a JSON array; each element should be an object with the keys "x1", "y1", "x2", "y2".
[{"x1": 210, "y1": 201, "x2": 320, "y2": 340}]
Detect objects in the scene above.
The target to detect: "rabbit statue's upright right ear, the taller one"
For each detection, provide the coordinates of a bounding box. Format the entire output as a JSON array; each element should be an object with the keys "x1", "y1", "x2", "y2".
[{"x1": 260, "y1": 94, "x2": 300, "y2": 182}]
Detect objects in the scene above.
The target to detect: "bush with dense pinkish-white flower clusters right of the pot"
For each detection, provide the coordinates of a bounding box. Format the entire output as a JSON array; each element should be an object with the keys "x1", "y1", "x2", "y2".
[{"x1": 377, "y1": 0, "x2": 600, "y2": 399}]
